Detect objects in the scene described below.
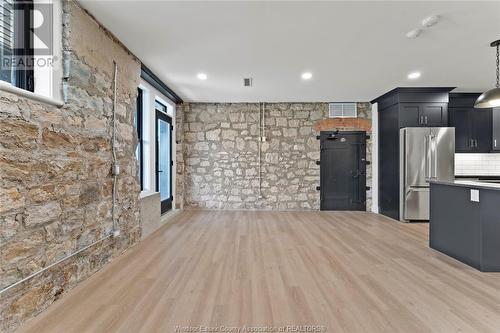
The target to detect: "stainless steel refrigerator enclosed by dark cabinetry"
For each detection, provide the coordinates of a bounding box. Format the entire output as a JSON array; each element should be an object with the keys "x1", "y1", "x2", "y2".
[{"x1": 399, "y1": 127, "x2": 455, "y2": 222}]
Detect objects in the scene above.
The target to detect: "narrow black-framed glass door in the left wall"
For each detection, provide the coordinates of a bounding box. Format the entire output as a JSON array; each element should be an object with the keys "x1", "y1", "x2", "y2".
[{"x1": 156, "y1": 109, "x2": 173, "y2": 214}]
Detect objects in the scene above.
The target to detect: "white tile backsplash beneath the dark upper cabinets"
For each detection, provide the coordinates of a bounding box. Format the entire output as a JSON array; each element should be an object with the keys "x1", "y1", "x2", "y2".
[{"x1": 455, "y1": 154, "x2": 500, "y2": 176}]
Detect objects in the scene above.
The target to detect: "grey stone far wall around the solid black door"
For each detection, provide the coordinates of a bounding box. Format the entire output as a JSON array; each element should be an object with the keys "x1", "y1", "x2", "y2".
[{"x1": 178, "y1": 103, "x2": 371, "y2": 210}]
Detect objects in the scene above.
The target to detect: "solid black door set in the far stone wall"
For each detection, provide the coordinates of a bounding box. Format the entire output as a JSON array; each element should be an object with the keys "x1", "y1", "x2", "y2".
[{"x1": 320, "y1": 131, "x2": 366, "y2": 211}]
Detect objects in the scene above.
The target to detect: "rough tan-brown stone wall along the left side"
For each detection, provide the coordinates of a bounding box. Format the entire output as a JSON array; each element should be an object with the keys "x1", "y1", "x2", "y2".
[{"x1": 0, "y1": 1, "x2": 140, "y2": 332}]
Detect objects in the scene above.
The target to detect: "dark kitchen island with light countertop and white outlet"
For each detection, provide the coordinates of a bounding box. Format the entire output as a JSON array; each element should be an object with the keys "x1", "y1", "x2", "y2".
[{"x1": 429, "y1": 180, "x2": 500, "y2": 272}]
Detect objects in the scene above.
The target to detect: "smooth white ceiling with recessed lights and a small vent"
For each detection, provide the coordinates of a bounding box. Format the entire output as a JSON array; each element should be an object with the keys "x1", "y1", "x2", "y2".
[{"x1": 80, "y1": 0, "x2": 500, "y2": 102}]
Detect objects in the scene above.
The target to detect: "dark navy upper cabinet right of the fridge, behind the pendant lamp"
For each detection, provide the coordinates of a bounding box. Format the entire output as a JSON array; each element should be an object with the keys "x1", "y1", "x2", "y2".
[{"x1": 448, "y1": 93, "x2": 493, "y2": 153}]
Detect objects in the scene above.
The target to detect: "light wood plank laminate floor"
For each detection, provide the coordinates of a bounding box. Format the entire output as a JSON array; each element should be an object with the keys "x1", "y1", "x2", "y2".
[{"x1": 20, "y1": 211, "x2": 500, "y2": 333}]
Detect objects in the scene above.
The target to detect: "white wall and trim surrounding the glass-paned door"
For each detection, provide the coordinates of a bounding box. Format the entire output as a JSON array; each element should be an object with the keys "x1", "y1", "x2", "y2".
[{"x1": 139, "y1": 79, "x2": 176, "y2": 207}]
